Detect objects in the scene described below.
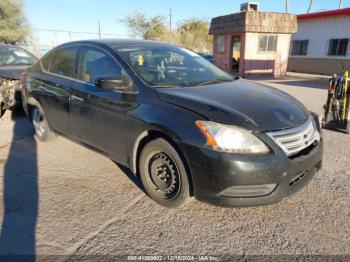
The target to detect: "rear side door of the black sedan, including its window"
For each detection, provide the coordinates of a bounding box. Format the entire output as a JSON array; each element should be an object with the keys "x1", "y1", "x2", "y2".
[{"x1": 32, "y1": 46, "x2": 78, "y2": 136}]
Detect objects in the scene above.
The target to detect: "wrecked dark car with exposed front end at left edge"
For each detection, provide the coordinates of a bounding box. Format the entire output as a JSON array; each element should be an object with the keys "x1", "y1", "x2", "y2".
[{"x1": 0, "y1": 44, "x2": 38, "y2": 118}]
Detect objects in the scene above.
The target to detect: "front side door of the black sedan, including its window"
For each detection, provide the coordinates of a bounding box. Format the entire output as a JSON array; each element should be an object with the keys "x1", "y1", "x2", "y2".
[{"x1": 70, "y1": 46, "x2": 135, "y2": 163}]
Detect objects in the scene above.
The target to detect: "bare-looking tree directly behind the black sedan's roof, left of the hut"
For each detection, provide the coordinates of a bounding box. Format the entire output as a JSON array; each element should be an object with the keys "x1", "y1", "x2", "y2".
[{"x1": 121, "y1": 13, "x2": 167, "y2": 40}]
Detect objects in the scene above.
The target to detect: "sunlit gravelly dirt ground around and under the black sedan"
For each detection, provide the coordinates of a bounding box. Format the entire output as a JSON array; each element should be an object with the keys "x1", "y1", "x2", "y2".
[{"x1": 0, "y1": 79, "x2": 350, "y2": 259}]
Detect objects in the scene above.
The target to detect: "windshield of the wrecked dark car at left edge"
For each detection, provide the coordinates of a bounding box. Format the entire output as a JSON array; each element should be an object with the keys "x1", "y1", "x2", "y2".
[{"x1": 0, "y1": 46, "x2": 38, "y2": 66}]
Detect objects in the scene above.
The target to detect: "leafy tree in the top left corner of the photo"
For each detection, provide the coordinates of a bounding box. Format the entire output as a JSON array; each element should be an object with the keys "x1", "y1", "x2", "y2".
[{"x1": 0, "y1": 0, "x2": 30, "y2": 44}]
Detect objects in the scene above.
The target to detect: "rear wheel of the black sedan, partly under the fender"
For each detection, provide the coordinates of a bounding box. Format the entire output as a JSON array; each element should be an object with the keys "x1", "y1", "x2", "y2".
[{"x1": 30, "y1": 104, "x2": 55, "y2": 142}]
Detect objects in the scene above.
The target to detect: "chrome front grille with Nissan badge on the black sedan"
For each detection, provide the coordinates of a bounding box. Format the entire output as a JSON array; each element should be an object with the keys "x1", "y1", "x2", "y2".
[{"x1": 267, "y1": 118, "x2": 320, "y2": 157}]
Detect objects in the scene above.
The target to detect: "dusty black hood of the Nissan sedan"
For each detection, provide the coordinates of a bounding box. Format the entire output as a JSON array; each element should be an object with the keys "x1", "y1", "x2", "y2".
[{"x1": 157, "y1": 79, "x2": 309, "y2": 131}]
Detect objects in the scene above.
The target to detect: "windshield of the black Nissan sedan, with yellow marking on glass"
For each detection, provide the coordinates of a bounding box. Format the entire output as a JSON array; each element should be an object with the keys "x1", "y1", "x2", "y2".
[{"x1": 114, "y1": 46, "x2": 234, "y2": 87}]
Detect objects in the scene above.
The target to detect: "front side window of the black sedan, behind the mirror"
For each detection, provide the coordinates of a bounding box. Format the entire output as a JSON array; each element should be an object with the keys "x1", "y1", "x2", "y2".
[{"x1": 78, "y1": 47, "x2": 122, "y2": 84}]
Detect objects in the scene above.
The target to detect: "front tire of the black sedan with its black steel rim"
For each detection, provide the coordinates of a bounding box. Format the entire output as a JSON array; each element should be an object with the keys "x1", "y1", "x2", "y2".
[{"x1": 139, "y1": 138, "x2": 190, "y2": 208}]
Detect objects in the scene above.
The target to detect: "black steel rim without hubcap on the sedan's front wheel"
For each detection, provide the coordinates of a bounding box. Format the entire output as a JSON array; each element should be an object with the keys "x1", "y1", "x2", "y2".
[{"x1": 148, "y1": 152, "x2": 180, "y2": 199}]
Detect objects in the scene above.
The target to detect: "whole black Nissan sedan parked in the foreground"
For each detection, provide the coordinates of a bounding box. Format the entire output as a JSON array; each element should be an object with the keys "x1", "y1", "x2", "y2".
[{"x1": 23, "y1": 40, "x2": 322, "y2": 207}]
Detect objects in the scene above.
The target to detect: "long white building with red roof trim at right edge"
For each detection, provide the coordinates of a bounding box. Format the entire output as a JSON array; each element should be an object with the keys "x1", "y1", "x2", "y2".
[{"x1": 288, "y1": 8, "x2": 350, "y2": 75}]
